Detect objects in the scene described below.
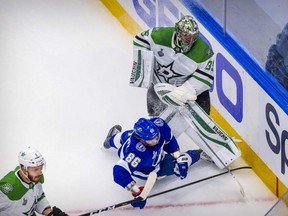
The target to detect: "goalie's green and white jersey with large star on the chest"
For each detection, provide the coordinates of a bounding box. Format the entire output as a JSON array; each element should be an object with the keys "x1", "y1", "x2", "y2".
[{"x1": 133, "y1": 27, "x2": 214, "y2": 95}]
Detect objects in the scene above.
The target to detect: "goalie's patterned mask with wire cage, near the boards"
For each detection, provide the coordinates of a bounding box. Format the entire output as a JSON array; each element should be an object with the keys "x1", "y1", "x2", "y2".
[{"x1": 175, "y1": 16, "x2": 199, "y2": 53}]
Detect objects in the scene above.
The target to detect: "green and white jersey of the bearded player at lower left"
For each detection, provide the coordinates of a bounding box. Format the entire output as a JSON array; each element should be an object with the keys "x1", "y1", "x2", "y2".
[{"x1": 0, "y1": 167, "x2": 50, "y2": 216}]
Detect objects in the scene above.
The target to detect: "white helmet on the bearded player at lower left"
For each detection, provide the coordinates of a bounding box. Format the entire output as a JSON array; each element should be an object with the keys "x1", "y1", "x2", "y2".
[{"x1": 18, "y1": 146, "x2": 46, "y2": 170}]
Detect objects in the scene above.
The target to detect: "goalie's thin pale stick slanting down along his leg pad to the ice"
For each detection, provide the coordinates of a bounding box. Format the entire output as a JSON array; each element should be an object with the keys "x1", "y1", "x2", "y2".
[{"x1": 180, "y1": 102, "x2": 245, "y2": 197}]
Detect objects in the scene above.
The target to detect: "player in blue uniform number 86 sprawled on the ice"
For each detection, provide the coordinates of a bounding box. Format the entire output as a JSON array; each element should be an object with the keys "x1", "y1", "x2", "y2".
[{"x1": 104, "y1": 118, "x2": 207, "y2": 209}]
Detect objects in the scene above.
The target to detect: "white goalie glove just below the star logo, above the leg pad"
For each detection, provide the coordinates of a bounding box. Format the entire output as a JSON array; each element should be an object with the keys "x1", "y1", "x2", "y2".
[{"x1": 154, "y1": 82, "x2": 197, "y2": 107}]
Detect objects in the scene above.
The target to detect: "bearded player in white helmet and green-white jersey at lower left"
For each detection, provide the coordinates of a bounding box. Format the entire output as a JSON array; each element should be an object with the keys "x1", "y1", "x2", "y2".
[{"x1": 0, "y1": 147, "x2": 67, "y2": 216}]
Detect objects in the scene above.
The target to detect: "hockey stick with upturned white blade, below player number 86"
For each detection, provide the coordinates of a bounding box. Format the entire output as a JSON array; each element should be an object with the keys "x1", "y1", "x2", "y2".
[{"x1": 78, "y1": 172, "x2": 157, "y2": 216}]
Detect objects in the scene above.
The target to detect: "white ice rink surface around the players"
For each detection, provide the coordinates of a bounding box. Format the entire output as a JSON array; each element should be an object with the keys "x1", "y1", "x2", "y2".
[{"x1": 0, "y1": 0, "x2": 277, "y2": 216}]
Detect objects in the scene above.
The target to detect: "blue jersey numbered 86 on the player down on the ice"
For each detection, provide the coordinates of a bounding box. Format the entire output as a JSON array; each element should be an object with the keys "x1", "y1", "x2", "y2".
[{"x1": 113, "y1": 118, "x2": 179, "y2": 188}]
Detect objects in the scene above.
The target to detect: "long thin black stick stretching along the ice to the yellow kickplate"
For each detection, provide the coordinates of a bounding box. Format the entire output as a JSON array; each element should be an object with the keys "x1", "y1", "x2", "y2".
[{"x1": 78, "y1": 166, "x2": 252, "y2": 216}]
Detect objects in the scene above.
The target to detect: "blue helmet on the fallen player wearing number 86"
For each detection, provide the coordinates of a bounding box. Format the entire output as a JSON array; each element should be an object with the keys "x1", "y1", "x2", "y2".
[{"x1": 134, "y1": 118, "x2": 159, "y2": 146}]
